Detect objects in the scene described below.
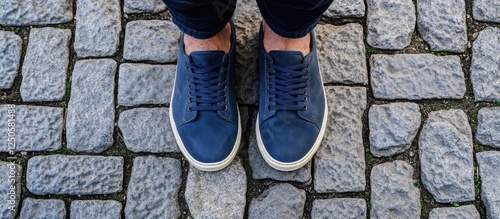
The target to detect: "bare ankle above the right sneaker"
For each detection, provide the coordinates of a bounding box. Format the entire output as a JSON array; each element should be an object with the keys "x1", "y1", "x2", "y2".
[{"x1": 262, "y1": 21, "x2": 311, "y2": 56}]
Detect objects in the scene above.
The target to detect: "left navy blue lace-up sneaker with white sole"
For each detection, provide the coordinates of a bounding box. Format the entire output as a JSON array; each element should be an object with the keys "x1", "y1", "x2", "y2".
[{"x1": 170, "y1": 22, "x2": 241, "y2": 171}]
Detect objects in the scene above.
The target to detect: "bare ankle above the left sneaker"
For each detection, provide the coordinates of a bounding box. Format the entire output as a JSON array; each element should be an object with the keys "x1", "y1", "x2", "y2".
[{"x1": 184, "y1": 23, "x2": 231, "y2": 55}]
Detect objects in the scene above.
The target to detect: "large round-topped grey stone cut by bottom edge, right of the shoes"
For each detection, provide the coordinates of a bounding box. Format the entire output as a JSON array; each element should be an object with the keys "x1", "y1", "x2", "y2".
[{"x1": 370, "y1": 160, "x2": 421, "y2": 219}]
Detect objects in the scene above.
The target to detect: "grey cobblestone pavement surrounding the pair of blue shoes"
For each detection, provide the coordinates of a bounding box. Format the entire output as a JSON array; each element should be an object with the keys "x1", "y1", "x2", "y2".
[{"x1": 0, "y1": 0, "x2": 500, "y2": 219}]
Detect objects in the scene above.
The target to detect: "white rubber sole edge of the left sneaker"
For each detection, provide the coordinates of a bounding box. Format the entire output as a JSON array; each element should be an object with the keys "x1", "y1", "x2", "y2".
[{"x1": 168, "y1": 69, "x2": 241, "y2": 172}]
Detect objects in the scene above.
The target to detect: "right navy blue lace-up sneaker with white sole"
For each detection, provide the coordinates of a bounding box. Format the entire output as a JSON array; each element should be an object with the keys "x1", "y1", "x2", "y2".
[{"x1": 256, "y1": 27, "x2": 328, "y2": 171}]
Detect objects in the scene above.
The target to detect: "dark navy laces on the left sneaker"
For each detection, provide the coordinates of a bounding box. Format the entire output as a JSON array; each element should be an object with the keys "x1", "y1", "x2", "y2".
[{"x1": 188, "y1": 62, "x2": 227, "y2": 111}]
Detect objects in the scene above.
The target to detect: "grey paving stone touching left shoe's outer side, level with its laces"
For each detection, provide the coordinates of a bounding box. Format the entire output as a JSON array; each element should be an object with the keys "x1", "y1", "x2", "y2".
[{"x1": 118, "y1": 64, "x2": 176, "y2": 106}]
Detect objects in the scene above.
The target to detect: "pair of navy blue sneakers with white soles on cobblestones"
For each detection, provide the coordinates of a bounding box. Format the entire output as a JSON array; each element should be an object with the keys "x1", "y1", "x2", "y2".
[{"x1": 170, "y1": 22, "x2": 327, "y2": 171}]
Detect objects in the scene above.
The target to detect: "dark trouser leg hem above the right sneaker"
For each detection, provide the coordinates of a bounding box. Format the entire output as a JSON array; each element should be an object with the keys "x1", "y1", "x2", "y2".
[{"x1": 257, "y1": 0, "x2": 333, "y2": 38}]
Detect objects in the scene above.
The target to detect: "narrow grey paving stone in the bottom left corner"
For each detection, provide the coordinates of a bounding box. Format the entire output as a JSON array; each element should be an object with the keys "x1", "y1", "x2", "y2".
[{"x1": 0, "y1": 161, "x2": 23, "y2": 219}]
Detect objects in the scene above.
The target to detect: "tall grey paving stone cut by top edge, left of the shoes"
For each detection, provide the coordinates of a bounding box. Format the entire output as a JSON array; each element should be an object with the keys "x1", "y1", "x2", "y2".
[{"x1": 74, "y1": 0, "x2": 122, "y2": 57}]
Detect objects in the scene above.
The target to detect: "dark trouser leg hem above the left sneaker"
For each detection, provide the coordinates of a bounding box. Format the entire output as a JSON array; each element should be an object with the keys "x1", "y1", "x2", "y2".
[{"x1": 163, "y1": 0, "x2": 236, "y2": 39}]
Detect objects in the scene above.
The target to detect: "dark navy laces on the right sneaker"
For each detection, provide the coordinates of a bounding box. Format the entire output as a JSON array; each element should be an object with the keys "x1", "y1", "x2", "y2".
[{"x1": 269, "y1": 57, "x2": 308, "y2": 111}]
